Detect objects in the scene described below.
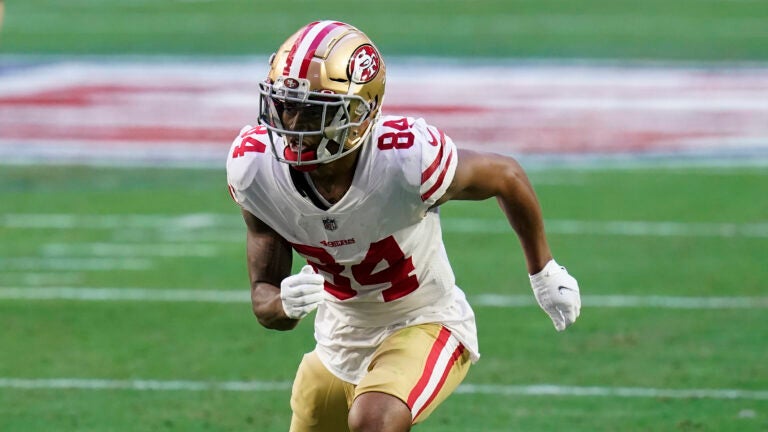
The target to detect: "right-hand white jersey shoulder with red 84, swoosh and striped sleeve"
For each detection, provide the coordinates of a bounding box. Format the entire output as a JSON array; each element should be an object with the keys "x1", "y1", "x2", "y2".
[{"x1": 372, "y1": 116, "x2": 458, "y2": 206}]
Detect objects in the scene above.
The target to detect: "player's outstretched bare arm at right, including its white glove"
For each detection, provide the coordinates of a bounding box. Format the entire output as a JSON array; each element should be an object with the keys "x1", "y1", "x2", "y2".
[{"x1": 435, "y1": 150, "x2": 581, "y2": 331}]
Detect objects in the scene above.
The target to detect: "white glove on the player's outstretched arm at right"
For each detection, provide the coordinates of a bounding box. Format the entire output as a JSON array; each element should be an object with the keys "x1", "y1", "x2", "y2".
[{"x1": 529, "y1": 260, "x2": 581, "y2": 331}]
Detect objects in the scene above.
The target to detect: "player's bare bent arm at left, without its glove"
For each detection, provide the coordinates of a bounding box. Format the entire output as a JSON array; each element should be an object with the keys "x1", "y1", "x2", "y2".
[{"x1": 242, "y1": 209, "x2": 299, "y2": 330}]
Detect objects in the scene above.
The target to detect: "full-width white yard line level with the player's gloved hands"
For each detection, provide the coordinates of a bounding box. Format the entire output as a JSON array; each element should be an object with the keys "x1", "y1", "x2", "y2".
[{"x1": 0, "y1": 287, "x2": 768, "y2": 309}]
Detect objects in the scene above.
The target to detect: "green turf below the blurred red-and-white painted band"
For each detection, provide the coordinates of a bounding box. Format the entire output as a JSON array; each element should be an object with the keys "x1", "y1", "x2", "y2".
[{"x1": 0, "y1": 166, "x2": 768, "y2": 431}]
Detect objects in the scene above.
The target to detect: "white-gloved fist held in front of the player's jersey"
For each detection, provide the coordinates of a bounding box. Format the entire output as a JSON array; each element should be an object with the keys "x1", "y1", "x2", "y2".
[{"x1": 280, "y1": 265, "x2": 325, "y2": 319}]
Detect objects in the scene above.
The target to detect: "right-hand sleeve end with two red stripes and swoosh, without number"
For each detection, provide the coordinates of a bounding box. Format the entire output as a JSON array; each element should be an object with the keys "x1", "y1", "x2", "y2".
[{"x1": 412, "y1": 119, "x2": 458, "y2": 207}]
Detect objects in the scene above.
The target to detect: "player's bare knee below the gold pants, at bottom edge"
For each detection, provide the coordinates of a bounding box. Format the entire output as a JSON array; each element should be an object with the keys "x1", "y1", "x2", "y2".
[{"x1": 347, "y1": 392, "x2": 411, "y2": 432}]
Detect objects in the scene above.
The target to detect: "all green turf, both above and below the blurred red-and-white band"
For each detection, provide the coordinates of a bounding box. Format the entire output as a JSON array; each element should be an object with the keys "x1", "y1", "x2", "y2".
[{"x1": 0, "y1": 0, "x2": 768, "y2": 432}]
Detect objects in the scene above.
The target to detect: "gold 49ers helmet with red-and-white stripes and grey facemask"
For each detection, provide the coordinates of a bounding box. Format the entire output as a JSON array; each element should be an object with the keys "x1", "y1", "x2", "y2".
[{"x1": 259, "y1": 21, "x2": 386, "y2": 171}]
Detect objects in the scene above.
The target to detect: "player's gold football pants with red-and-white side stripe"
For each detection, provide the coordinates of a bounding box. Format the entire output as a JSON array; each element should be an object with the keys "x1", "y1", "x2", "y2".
[{"x1": 290, "y1": 324, "x2": 471, "y2": 432}]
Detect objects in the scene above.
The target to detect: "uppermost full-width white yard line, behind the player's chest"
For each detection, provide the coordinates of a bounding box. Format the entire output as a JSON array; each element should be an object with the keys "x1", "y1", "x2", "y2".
[{"x1": 0, "y1": 213, "x2": 768, "y2": 238}]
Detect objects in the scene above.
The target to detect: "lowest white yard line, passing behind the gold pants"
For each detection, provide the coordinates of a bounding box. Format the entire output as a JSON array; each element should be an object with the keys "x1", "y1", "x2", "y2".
[{"x1": 0, "y1": 378, "x2": 768, "y2": 400}]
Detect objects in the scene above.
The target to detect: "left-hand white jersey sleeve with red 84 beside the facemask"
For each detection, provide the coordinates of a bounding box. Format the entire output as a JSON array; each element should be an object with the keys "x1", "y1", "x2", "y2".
[{"x1": 227, "y1": 126, "x2": 269, "y2": 206}]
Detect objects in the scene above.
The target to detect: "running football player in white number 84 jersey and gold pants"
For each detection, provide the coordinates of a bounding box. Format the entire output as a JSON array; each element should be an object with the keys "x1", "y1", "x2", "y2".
[{"x1": 227, "y1": 21, "x2": 581, "y2": 432}]
